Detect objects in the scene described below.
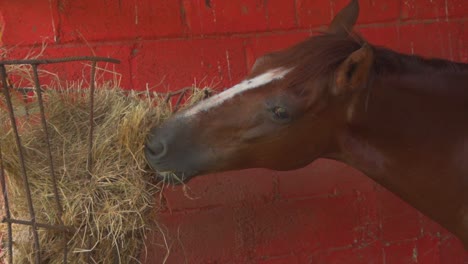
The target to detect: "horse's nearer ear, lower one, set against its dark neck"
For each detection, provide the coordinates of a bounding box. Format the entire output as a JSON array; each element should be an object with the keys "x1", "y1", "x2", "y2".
[{"x1": 332, "y1": 43, "x2": 374, "y2": 95}]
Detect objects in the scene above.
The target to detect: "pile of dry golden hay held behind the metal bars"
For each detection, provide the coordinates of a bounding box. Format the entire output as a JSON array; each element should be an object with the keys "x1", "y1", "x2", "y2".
[{"x1": 0, "y1": 63, "x2": 209, "y2": 263}]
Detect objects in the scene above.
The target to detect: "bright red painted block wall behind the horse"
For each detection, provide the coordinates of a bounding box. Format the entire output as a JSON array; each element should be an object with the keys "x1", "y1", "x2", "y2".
[{"x1": 0, "y1": 0, "x2": 468, "y2": 264}]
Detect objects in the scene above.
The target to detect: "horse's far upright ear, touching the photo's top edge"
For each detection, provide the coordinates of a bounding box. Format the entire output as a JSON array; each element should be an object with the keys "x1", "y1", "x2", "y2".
[{"x1": 328, "y1": 0, "x2": 359, "y2": 35}]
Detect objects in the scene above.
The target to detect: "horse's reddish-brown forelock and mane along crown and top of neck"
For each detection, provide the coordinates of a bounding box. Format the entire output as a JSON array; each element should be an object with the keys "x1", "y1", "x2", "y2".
[{"x1": 272, "y1": 32, "x2": 468, "y2": 87}]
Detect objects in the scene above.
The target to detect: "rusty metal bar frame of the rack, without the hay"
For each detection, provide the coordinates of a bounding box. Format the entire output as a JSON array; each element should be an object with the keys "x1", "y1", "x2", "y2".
[{"x1": 0, "y1": 57, "x2": 119, "y2": 264}]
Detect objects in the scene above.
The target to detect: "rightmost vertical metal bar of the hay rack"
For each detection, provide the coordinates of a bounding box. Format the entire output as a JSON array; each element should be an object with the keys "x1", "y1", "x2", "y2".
[{"x1": 86, "y1": 61, "x2": 96, "y2": 263}]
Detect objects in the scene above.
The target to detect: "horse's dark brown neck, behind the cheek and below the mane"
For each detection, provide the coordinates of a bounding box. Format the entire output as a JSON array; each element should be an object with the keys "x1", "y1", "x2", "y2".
[{"x1": 336, "y1": 60, "x2": 468, "y2": 239}]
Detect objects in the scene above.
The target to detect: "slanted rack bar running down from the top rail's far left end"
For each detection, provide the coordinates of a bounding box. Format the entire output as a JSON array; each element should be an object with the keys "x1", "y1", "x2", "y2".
[{"x1": 0, "y1": 65, "x2": 41, "y2": 264}]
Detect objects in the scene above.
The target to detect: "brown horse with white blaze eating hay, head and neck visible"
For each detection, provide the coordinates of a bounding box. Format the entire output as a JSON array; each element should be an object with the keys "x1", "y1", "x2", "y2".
[{"x1": 146, "y1": 0, "x2": 468, "y2": 248}]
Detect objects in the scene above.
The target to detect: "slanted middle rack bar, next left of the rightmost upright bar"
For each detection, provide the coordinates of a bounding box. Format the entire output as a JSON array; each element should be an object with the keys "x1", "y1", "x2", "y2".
[{"x1": 32, "y1": 64, "x2": 68, "y2": 263}]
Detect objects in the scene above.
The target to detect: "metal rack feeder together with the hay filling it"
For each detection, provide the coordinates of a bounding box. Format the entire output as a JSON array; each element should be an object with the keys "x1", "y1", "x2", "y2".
[{"x1": 0, "y1": 57, "x2": 209, "y2": 263}]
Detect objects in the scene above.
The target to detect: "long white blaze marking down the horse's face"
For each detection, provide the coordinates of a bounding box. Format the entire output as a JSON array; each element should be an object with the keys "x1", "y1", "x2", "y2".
[{"x1": 182, "y1": 68, "x2": 291, "y2": 117}]
